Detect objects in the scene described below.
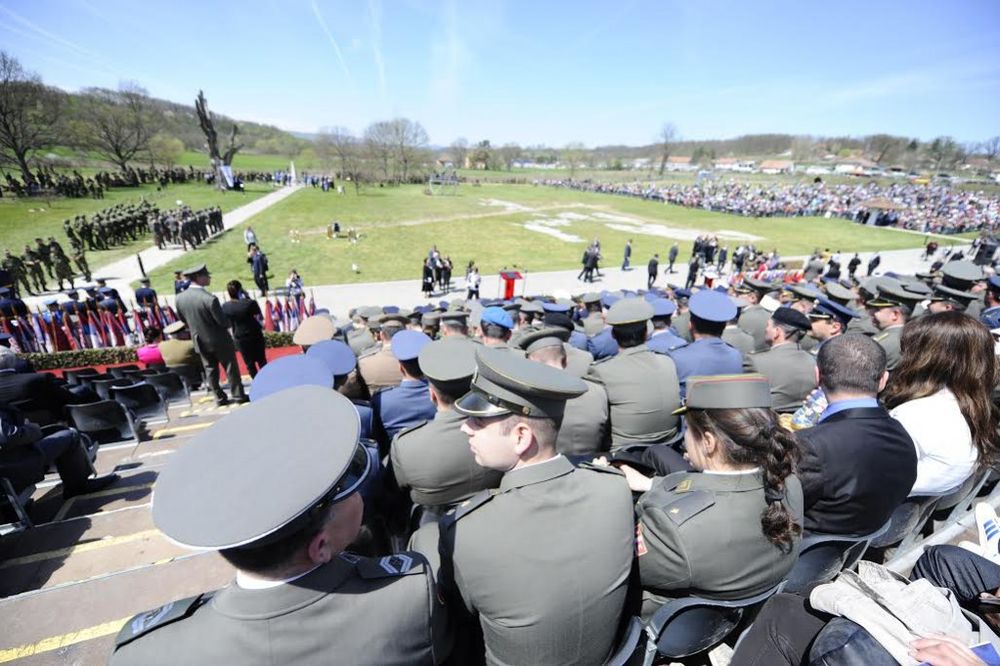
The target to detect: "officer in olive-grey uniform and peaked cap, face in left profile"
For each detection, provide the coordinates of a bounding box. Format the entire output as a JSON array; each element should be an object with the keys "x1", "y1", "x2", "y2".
[{"x1": 440, "y1": 347, "x2": 632, "y2": 665}]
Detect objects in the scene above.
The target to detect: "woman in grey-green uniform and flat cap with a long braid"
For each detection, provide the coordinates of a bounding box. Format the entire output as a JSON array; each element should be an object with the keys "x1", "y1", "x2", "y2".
[{"x1": 600, "y1": 374, "x2": 803, "y2": 617}]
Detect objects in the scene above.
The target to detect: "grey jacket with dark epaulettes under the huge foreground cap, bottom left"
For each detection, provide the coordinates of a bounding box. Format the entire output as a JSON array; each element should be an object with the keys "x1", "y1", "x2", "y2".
[{"x1": 110, "y1": 552, "x2": 448, "y2": 666}]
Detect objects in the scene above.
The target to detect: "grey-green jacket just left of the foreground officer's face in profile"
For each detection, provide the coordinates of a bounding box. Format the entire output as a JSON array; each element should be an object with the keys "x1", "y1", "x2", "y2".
[{"x1": 389, "y1": 409, "x2": 503, "y2": 507}]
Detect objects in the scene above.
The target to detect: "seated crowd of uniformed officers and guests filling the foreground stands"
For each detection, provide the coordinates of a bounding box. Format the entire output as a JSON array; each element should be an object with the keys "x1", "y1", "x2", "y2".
[{"x1": 0, "y1": 253, "x2": 1000, "y2": 664}]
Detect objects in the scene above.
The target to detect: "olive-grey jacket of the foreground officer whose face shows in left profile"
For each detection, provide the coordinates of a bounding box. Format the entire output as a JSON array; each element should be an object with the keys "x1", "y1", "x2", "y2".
[{"x1": 441, "y1": 456, "x2": 634, "y2": 666}]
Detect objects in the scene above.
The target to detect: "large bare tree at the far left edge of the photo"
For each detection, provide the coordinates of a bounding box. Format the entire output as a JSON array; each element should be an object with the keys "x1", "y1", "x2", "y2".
[{"x1": 0, "y1": 51, "x2": 64, "y2": 184}]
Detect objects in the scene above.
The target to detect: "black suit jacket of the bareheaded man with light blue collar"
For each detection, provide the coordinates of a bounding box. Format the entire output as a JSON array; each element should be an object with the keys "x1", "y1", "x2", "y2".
[{"x1": 796, "y1": 407, "x2": 917, "y2": 534}]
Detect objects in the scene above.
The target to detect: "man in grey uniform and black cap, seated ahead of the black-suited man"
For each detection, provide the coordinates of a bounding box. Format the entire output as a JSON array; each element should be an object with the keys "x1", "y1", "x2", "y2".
[{"x1": 747, "y1": 308, "x2": 816, "y2": 413}]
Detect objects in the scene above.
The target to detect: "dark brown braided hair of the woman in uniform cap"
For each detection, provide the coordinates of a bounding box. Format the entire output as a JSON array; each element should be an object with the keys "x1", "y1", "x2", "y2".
[{"x1": 687, "y1": 407, "x2": 802, "y2": 552}]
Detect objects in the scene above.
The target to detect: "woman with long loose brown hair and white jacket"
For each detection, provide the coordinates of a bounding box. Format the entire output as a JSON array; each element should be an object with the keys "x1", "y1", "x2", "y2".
[{"x1": 882, "y1": 311, "x2": 998, "y2": 495}]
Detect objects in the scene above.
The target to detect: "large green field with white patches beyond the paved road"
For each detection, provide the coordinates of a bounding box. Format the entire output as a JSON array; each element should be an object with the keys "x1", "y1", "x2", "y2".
[{"x1": 143, "y1": 185, "x2": 944, "y2": 293}]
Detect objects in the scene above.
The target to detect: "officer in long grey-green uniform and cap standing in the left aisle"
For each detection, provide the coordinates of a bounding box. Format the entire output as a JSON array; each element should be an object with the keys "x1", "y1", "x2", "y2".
[{"x1": 177, "y1": 264, "x2": 247, "y2": 405}]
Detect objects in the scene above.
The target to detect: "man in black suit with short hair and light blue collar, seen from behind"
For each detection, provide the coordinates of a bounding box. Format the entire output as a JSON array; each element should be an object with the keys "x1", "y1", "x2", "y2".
[{"x1": 798, "y1": 333, "x2": 917, "y2": 535}]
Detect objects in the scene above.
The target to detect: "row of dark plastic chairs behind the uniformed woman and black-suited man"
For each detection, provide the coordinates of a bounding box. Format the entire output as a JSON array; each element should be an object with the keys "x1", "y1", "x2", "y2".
[{"x1": 608, "y1": 468, "x2": 993, "y2": 666}]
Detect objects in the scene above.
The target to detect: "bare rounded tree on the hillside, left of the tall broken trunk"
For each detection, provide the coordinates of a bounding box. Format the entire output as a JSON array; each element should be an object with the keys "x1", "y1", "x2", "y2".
[{"x1": 80, "y1": 81, "x2": 154, "y2": 171}]
